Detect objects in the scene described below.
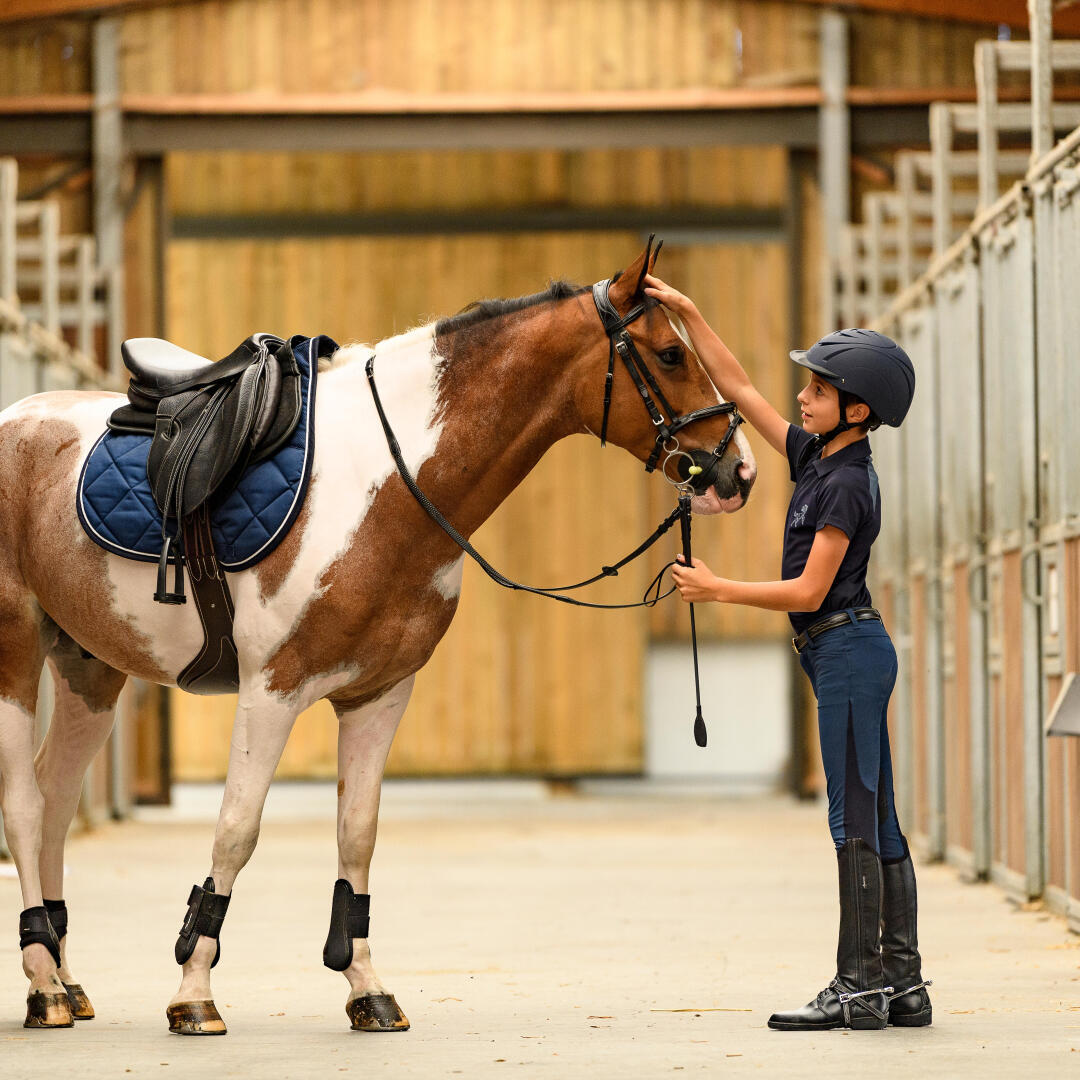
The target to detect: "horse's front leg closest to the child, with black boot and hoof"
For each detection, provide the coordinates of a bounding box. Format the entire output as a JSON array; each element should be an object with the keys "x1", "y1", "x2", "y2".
[{"x1": 323, "y1": 676, "x2": 413, "y2": 1031}]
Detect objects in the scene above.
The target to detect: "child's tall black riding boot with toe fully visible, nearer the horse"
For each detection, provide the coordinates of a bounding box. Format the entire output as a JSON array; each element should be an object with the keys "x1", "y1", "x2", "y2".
[{"x1": 769, "y1": 839, "x2": 889, "y2": 1031}]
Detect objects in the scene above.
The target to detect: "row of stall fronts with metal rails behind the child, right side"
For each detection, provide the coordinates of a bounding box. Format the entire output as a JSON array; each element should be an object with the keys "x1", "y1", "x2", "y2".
[{"x1": 835, "y1": 0, "x2": 1080, "y2": 929}]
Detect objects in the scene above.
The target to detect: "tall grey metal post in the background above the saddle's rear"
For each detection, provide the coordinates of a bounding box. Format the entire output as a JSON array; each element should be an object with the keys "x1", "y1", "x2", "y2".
[{"x1": 93, "y1": 15, "x2": 124, "y2": 375}]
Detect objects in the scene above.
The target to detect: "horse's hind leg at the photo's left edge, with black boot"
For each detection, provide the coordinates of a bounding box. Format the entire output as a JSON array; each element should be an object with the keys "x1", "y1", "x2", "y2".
[{"x1": 0, "y1": 600, "x2": 72, "y2": 1027}]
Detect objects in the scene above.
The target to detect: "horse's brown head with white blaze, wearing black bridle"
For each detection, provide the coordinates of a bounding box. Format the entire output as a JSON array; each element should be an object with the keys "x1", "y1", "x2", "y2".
[{"x1": 578, "y1": 237, "x2": 757, "y2": 514}]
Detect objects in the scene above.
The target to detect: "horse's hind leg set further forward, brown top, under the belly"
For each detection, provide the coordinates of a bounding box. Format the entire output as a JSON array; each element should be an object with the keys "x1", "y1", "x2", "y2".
[{"x1": 36, "y1": 633, "x2": 127, "y2": 1020}]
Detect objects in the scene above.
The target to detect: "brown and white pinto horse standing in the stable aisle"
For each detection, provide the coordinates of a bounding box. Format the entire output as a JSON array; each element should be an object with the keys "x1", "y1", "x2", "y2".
[{"x1": 0, "y1": 240, "x2": 756, "y2": 1035}]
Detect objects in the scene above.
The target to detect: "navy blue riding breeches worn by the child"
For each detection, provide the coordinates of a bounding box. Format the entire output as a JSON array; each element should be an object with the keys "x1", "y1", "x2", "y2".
[{"x1": 799, "y1": 620, "x2": 907, "y2": 861}]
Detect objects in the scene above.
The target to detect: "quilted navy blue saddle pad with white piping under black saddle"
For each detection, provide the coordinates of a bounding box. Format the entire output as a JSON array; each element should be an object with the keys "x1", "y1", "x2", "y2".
[{"x1": 76, "y1": 334, "x2": 338, "y2": 572}]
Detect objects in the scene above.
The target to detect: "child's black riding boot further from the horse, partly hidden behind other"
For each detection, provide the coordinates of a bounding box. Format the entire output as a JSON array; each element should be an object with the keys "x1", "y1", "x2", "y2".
[{"x1": 881, "y1": 840, "x2": 933, "y2": 1027}]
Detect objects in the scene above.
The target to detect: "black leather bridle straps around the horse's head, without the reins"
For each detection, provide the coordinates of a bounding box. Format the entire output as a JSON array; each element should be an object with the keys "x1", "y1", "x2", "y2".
[{"x1": 593, "y1": 278, "x2": 742, "y2": 487}]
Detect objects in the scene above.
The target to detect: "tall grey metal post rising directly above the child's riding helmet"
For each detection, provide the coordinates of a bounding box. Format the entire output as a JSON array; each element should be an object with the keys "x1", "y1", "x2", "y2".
[{"x1": 818, "y1": 11, "x2": 851, "y2": 330}]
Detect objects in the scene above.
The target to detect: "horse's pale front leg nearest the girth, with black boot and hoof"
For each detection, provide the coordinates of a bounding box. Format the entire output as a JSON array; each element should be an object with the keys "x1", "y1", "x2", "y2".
[{"x1": 165, "y1": 687, "x2": 296, "y2": 1035}]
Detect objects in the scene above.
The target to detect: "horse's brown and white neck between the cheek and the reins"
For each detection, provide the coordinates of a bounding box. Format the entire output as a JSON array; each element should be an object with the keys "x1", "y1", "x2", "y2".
[{"x1": 329, "y1": 319, "x2": 578, "y2": 544}]
